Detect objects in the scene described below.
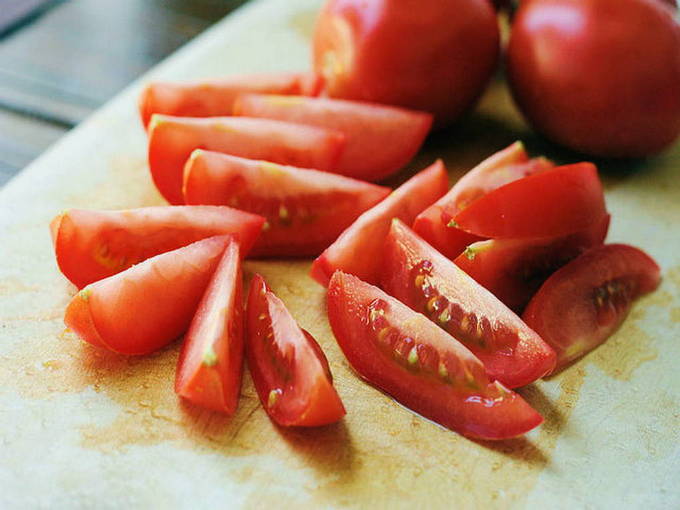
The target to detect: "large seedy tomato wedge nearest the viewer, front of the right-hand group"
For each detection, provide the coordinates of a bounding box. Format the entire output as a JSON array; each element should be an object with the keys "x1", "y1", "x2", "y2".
[{"x1": 328, "y1": 271, "x2": 543, "y2": 439}]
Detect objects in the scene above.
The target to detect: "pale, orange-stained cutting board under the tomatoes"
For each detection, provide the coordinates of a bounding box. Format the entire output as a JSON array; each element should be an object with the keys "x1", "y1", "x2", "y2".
[{"x1": 0, "y1": 0, "x2": 680, "y2": 508}]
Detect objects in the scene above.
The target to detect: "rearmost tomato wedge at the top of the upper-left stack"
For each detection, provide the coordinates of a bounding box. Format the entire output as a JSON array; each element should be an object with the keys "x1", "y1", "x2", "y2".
[{"x1": 139, "y1": 73, "x2": 322, "y2": 127}]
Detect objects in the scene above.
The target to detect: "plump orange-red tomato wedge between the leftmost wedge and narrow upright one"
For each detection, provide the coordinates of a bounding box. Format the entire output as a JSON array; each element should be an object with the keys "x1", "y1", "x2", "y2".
[{"x1": 64, "y1": 236, "x2": 230, "y2": 354}]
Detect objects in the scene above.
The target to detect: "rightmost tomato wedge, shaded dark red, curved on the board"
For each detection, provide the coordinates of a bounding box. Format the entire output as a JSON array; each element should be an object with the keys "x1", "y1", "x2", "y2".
[{"x1": 523, "y1": 244, "x2": 661, "y2": 368}]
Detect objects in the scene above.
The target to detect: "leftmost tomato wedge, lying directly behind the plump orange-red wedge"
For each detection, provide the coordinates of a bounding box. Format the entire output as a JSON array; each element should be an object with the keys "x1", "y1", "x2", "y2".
[{"x1": 50, "y1": 206, "x2": 265, "y2": 288}]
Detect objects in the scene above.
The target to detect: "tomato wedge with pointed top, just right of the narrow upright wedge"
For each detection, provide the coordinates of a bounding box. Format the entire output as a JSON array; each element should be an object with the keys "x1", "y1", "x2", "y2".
[{"x1": 246, "y1": 274, "x2": 345, "y2": 427}]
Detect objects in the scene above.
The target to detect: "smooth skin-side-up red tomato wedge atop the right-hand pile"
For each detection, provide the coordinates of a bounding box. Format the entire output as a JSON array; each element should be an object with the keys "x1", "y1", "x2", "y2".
[{"x1": 453, "y1": 163, "x2": 607, "y2": 239}]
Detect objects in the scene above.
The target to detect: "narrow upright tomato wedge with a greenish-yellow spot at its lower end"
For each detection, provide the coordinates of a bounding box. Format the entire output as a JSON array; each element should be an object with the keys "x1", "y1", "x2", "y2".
[{"x1": 175, "y1": 241, "x2": 243, "y2": 414}]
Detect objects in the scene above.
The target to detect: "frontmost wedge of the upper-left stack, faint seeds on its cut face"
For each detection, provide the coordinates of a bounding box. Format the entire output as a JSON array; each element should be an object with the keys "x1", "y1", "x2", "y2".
[{"x1": 184, "y1": 151, "x2": 390, "y2": 257}]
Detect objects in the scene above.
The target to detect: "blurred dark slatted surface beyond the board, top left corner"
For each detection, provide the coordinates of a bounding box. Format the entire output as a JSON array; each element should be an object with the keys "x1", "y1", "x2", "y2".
[{"x1": 0, "y1": 0, "x2": 247, "y2": 186}]
